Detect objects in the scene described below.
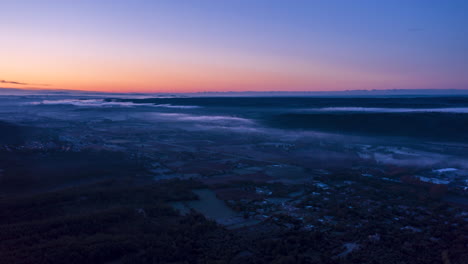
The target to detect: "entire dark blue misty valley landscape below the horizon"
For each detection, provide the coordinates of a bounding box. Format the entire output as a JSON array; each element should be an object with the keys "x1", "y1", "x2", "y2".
[{"x1": 0, "y1": 92, "x2": 468, "y2": 263}]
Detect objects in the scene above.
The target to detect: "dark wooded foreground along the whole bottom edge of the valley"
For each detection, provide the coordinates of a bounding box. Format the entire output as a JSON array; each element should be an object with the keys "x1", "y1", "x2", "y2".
[{"x1": 0, "y1": 174, "x2": 468, "y2": 264}]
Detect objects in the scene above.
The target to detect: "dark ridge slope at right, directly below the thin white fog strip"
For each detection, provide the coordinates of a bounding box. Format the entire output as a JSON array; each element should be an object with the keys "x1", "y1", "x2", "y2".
[{"x1": 266, "y1": 113, "x2": 468, "y2": 142}]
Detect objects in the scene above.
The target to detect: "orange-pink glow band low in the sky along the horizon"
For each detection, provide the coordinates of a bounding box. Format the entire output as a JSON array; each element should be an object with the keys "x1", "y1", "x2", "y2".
[{"x1": 0, "y1": 53, "x2": 456, "y2": 93}]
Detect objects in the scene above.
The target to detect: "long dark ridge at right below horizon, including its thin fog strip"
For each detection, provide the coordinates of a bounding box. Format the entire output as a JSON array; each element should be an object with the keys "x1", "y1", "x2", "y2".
[{"x1": 107, "y1": 97, "x2": 468, "y2": 141}]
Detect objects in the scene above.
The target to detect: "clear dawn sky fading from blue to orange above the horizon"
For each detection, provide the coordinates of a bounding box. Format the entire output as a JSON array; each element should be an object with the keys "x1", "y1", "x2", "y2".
[{"x1": 0, "y1": 0, "x2": 468, "y2": 92}]
